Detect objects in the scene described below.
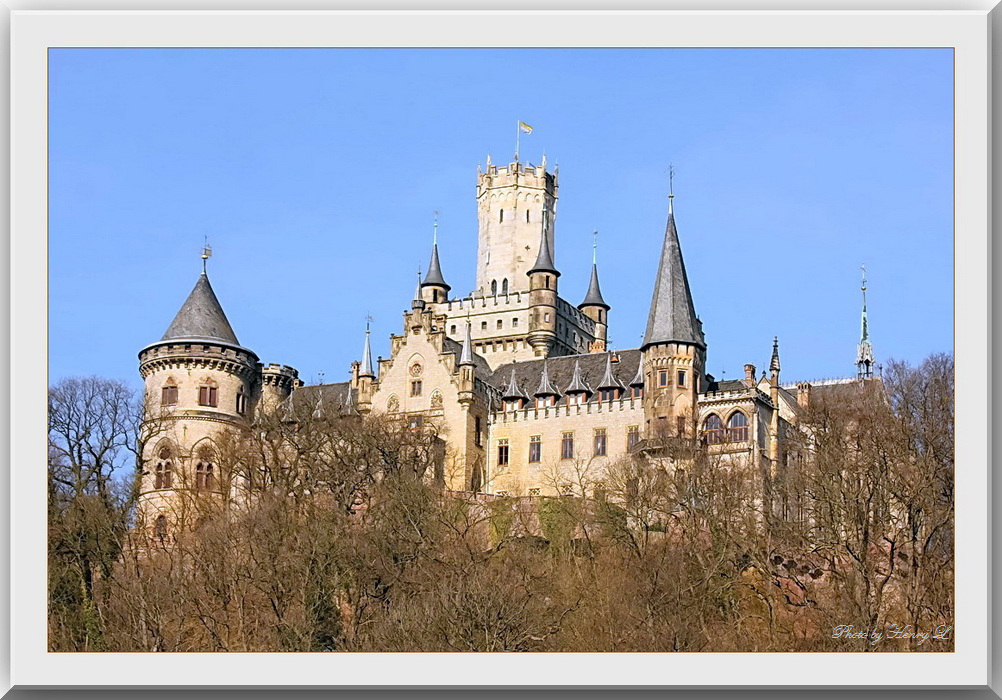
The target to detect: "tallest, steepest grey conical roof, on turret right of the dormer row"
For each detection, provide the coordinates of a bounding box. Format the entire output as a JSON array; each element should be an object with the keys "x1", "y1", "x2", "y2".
[{"x1": 642, "y1": 199, "x2": 705, "y2": 347}]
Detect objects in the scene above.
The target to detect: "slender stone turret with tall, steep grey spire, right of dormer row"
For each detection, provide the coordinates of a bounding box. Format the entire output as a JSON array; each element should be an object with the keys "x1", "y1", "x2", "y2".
[{"x1": 640, "y1": 182, "x2": 706, "y2": 437}]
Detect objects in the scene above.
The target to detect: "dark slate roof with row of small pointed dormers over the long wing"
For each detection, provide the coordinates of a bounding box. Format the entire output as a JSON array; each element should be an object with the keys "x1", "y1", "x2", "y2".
[{"x1": 489, "y1": 349, "x2": 640, "y2": 397}]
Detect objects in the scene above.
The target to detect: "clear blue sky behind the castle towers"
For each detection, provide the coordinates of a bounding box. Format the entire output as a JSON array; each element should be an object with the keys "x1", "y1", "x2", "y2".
[{"x1": 49, "y1": 49, "x2": 953, "y2": 386}]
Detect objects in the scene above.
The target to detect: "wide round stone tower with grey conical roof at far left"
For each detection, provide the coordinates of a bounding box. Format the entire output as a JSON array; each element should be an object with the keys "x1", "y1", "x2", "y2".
[{"x1": 136, "y1": 271, "x2": 258, "y2": 544}]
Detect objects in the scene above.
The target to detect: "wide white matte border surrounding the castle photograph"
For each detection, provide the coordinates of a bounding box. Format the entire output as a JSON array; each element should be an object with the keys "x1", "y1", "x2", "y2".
[{"x1": 11, "y1": 11, "x2": 989, "y2": 686}]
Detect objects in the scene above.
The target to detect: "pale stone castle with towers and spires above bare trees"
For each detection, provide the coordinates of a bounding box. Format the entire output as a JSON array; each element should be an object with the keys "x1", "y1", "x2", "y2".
[{"x1": 138, "y1": 153, "x2": 874, "y2": 537}]
